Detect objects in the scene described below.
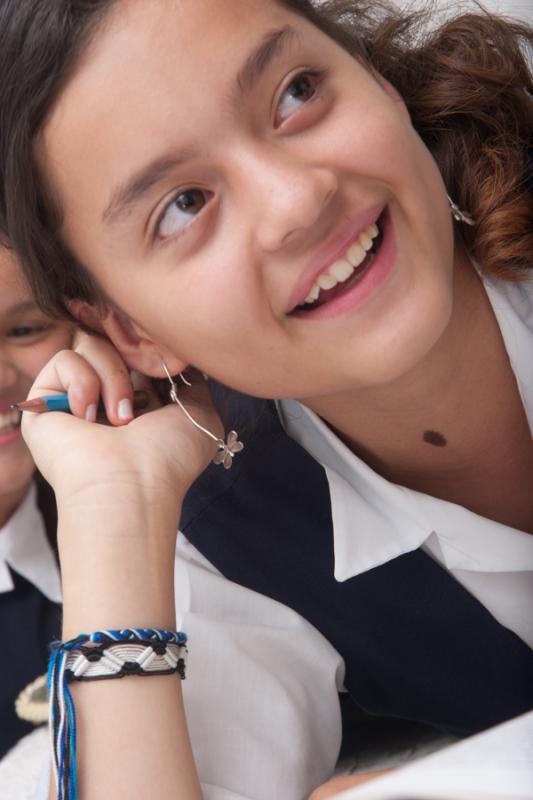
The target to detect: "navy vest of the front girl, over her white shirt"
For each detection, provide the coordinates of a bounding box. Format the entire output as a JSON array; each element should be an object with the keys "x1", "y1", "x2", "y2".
[{"x1": 181, "y1": 400, "x2": 533, "y2": 736}]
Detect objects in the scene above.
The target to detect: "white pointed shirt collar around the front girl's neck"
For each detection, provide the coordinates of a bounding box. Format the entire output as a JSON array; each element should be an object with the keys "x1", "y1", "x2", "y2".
[{"x1": 277, "y1": 280, "x2": 533, "y2": 581}]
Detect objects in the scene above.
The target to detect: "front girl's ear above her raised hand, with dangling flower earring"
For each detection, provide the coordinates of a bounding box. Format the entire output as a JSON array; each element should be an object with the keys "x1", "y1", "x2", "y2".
[{"x1": 69, "y1": 300, "x2": 188, "y2": 378}]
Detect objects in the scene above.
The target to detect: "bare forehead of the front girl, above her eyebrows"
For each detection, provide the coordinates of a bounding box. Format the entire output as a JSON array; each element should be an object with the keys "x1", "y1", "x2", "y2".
[{"x1": 42, "y1": 0, "x2": 315, "y2": 222}]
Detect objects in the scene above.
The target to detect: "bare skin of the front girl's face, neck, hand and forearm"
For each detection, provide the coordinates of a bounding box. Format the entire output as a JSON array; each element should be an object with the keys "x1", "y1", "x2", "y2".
[{"x1": 17, "y1": 0, "x2": 533, "y2": 800}]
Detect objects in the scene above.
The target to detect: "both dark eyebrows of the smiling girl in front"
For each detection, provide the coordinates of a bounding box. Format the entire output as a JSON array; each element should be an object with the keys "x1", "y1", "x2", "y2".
[{"x1": 102, "y1": 25, "x2": 300, "y2": 225}]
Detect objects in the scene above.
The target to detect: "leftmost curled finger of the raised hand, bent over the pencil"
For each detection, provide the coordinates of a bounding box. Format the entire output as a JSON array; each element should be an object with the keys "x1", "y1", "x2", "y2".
[{"x1": 28, "y1": 350, "x2": 100, "y2": 422}]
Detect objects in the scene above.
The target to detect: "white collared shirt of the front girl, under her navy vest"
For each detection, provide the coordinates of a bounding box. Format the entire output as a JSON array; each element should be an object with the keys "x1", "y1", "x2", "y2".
[{"x1": 169, "y1": 280, "x2": 533, "y2": 800}]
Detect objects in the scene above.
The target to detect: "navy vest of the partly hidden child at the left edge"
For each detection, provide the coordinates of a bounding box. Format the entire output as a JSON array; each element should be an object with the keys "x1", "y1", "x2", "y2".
[{"x1": 0, "y1": 480, "x2": 61, "y2": 758}]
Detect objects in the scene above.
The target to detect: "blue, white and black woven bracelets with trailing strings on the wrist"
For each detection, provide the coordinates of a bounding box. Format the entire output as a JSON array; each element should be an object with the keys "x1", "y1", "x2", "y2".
[{"x1": 48, "y1": 628, "x2": 187, "y2": 800}]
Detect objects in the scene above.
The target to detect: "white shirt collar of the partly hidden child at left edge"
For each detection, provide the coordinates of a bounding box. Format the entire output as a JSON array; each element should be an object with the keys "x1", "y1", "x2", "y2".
[{"x1": 0, "y1": 483, "x2": 61, "y2": 603}]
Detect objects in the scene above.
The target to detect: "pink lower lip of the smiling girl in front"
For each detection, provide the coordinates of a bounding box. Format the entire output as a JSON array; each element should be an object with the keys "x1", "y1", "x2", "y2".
[{"x1": 291, "y1": 211, "x2": 396, "y2": 320}]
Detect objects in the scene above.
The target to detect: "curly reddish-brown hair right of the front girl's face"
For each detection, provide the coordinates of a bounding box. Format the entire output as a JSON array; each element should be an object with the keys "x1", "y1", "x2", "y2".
[{"x1": 281, "y1": 0, "x2": 533, "y2": 281}]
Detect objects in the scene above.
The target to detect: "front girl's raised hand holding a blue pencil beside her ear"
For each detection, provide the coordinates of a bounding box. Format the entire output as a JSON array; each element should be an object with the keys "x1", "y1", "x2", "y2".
[{"x1": 22, "y1": 335, "x2": 222, "y2": 506}]
